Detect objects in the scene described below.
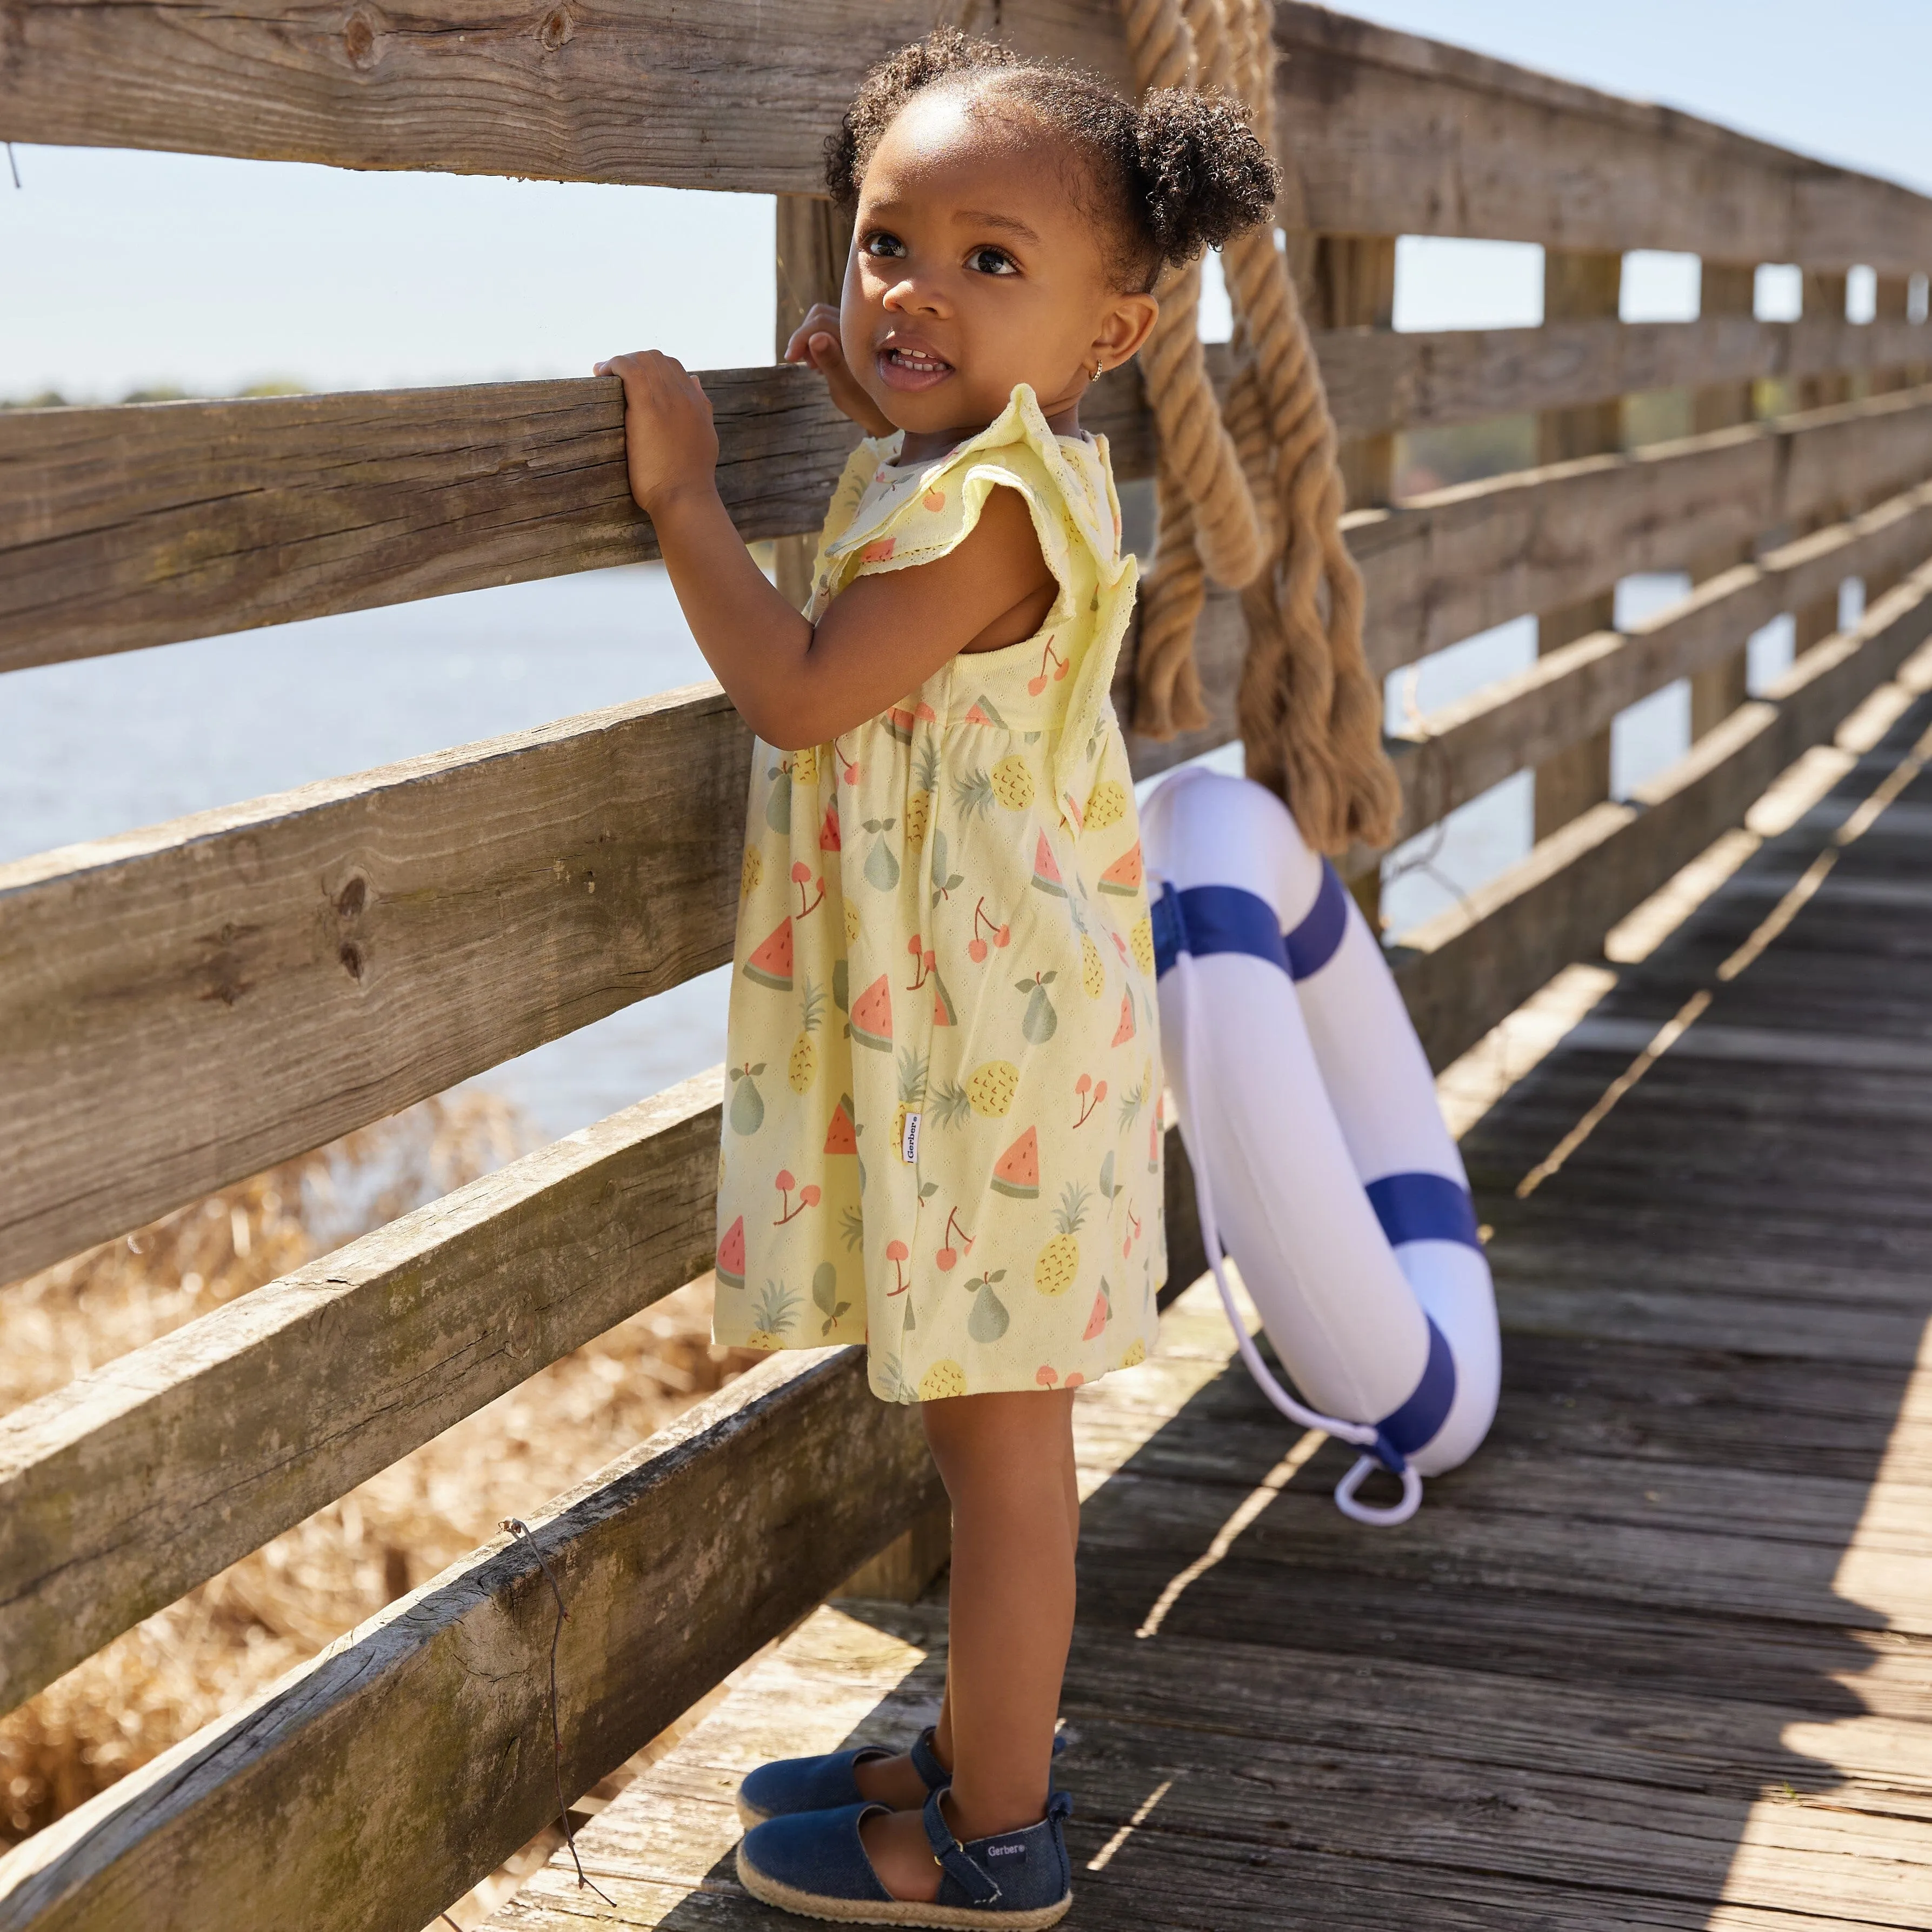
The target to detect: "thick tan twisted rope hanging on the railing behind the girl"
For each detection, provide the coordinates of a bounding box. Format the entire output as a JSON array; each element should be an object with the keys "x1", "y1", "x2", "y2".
[{"x1": 1121, "y1": 0, "x2": 1401, "y2": 852}]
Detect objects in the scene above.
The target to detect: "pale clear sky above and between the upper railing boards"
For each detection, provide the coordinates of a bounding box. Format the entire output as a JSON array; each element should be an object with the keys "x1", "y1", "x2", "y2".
[{"x1": 0, "y1": 0, "x2": 1932, "y2": 400}]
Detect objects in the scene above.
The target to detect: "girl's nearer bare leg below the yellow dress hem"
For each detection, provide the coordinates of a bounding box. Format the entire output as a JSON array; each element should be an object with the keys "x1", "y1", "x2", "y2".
[{"x1": 860, "y1": 1391, "x2": 1078, "y2": 1899}]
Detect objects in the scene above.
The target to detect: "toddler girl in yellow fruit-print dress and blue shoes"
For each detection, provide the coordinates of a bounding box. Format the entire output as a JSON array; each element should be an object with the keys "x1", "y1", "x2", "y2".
[{"x1": 599, "y1": 33, "x2": 1275, "y2": 1926}]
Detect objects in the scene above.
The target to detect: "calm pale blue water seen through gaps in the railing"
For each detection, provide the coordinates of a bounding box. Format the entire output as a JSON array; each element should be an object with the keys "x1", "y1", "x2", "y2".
[{"x1": 0, "y1": 564, "x2": 1823, "y2": 1136}]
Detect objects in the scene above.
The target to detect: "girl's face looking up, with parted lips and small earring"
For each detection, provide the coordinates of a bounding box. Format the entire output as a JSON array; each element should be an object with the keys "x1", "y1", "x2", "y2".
[{"x1": 841, "y1": 93, "x2": 1157, "y2": 448}]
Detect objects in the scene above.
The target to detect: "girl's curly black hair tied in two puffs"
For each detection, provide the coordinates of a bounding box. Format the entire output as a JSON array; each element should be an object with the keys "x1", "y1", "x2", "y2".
[{"x1": 825, "y1": 27, "x2": 1281, "y2": 290}]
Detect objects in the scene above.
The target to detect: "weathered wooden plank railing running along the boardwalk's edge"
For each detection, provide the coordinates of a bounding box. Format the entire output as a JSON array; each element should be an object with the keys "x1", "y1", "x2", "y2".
[{"x1": 0, "y1": 0, "x2": 1932, "y2": 1932}]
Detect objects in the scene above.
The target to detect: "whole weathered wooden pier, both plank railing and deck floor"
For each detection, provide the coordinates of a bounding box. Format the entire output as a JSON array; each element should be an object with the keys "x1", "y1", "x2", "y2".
[{"x1": 0, "y1": 0, "x2": 1932, "y2": 1932}]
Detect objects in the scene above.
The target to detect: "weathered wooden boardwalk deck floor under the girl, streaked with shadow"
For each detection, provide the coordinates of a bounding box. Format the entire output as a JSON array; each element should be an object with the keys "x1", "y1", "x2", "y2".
[{"x1": 495, "y1": 688, "x2": 1932, "y2": 1932}]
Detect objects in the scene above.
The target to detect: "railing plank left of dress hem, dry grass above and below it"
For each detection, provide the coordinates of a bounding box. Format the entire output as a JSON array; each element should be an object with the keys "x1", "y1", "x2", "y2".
[{"x1": 0, "y1": 1068, "x2": 723, "y2": 1710}]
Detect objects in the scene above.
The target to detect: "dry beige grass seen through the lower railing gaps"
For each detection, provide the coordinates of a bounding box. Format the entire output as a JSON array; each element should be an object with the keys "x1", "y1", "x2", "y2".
[{"x1": 0, "y1": 1094, "x2": 757, "y2": 1862}]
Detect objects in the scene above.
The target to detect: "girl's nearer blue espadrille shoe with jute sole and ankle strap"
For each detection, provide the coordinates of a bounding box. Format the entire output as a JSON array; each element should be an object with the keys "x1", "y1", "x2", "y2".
[{"x1": 738, "y1": 1791, "x2": 1074, "y2": 1932}]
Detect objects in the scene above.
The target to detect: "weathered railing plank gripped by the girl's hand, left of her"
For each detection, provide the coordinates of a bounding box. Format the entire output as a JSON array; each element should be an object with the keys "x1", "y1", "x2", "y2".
[{"x1": 0, "y1": 369, "x2": 858, "y2": 670}]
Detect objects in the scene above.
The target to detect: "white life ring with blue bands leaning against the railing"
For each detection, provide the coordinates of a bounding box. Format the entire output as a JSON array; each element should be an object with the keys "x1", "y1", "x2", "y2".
[{"x1": 1142, "y1": 767, "x2": 1501, "y2": 1522}]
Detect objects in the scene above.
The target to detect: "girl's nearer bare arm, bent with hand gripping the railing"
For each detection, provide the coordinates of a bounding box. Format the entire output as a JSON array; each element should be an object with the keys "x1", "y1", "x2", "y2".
[{"x1": 597, "y1": 350, "x2": 1055, "y2": 750}]
